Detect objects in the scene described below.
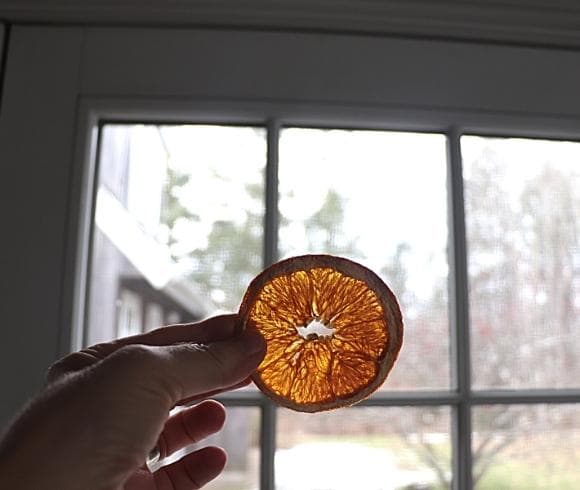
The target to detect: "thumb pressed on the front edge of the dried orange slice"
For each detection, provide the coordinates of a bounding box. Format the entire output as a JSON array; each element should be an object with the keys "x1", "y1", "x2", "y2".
[{"x1": 127, "y1": 330, "x2": 266, "y2": 404}]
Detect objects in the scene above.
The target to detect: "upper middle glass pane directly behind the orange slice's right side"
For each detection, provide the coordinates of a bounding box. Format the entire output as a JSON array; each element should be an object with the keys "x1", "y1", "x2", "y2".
[{"x1": 279, "y1": 128, "x2": 449, "y2": 389}]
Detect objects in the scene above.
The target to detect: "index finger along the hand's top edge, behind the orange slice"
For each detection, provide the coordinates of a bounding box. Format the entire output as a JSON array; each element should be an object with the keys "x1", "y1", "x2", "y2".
[{"x1": 47, "y1": 314, "x2": 239, "y2": 383}]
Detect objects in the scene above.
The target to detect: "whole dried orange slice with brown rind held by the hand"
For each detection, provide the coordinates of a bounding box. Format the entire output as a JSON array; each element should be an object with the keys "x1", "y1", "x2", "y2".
[{"x1": 240, "y1": 255, "x2": 403, "y2": 412}]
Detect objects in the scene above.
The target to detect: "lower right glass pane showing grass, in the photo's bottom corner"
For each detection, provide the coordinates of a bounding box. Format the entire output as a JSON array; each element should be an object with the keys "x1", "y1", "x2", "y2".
[{"x1": 473, "y1": 405, "x2": 580, "y2": 490}]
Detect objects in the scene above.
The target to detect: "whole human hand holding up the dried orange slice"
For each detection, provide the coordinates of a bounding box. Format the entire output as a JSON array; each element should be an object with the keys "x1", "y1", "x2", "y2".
[{"x1": 0, "y1": 315, "x2": 265, "y2": 490}]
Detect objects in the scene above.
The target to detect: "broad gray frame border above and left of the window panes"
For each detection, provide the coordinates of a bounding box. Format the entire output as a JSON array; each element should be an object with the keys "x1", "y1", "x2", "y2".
[{"x1": 0, "y1": 22, "x2": 580, "y2": 424}]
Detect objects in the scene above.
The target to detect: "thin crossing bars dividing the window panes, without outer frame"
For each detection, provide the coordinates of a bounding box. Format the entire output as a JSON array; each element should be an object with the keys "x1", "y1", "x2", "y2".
[{"x1": 205, "y1": 119, "x2": 580, "y2": 490}]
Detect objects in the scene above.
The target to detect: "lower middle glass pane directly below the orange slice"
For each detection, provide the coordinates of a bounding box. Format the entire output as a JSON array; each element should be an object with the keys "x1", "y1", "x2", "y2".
[{"x1": 275, "y1": 407, "x2": 451, "y2": 490}]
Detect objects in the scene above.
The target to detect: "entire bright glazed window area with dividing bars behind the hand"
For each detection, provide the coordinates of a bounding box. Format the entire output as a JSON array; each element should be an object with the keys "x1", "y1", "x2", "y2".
[{"x1": 89, "y1": 123, "x2": 580, "y2": 490}]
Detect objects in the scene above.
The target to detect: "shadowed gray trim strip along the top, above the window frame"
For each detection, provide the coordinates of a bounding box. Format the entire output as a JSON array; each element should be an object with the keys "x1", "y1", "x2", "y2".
[{"x1": 0, "y1": 0, "x2": 580, "y2": 47}]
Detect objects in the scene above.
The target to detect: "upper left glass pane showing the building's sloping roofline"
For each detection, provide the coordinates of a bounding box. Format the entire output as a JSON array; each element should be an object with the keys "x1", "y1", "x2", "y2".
[{"x1": 87, "y1": 125, "x2": 266, "y2": 344}]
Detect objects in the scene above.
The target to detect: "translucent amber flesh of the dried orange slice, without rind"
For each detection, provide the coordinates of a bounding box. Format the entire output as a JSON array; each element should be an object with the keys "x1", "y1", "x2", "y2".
[{"x1": 249, "y1": 268, "x2": 388, "y2": 404}]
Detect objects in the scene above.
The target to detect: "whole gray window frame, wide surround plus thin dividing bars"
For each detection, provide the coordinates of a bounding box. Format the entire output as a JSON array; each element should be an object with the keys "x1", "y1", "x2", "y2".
[{"x1": 0, "y1": 26, "x2": 580, "y2": 489}]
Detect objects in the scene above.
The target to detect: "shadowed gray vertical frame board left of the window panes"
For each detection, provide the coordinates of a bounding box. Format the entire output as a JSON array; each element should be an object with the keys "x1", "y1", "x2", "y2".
[{"x1": 0, "y1": 27, "x2": 80, "y2": 425}]
